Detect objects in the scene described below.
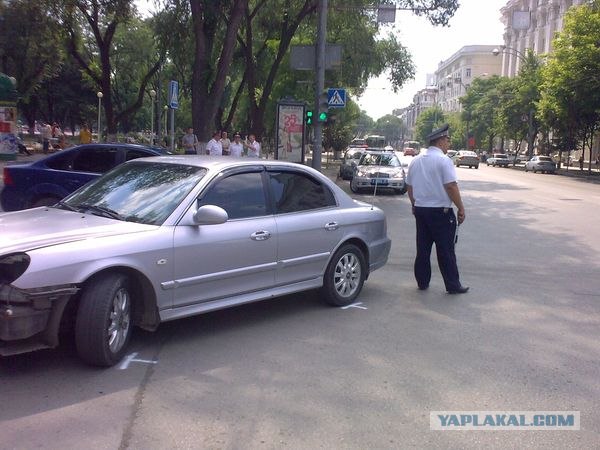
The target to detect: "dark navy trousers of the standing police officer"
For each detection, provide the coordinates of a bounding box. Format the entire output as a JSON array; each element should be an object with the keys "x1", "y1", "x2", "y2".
[{"x1": 414, "y1": 206, "x2": 461, "y2": 291}]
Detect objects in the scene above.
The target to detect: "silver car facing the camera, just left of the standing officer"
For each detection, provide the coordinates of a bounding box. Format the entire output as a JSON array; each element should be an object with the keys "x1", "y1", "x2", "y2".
[{"x1": 350, "y1": 151, "x2": 406, "y2": 195}]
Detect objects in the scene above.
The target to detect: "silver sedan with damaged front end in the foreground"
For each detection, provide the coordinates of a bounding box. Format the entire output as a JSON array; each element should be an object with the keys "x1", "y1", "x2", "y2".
[{"x1": 0, "y1": 156, "x2": 391, "y2": 366}]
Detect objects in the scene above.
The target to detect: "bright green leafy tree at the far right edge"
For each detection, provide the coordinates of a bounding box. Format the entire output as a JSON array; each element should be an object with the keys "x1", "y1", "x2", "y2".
[{"x1": 539, "y1": 0, "x2": 600, "y2": 171}]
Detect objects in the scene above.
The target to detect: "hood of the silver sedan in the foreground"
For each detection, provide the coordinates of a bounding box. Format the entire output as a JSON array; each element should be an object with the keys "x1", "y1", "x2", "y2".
[{"x1": 0, "y1": 208, "x2": 156, "y2": 255}]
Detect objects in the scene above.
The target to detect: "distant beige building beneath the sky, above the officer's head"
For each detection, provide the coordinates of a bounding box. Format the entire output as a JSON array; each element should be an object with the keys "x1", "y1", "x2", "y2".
[{"x1": 435, "y1": 45, "x2": 502, "y2": 112}]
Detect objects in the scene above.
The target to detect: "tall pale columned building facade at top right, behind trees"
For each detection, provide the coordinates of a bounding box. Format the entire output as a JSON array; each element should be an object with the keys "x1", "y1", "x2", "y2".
[{"x1": 499, "y1": 0, "x2": 585, "y2": 77}]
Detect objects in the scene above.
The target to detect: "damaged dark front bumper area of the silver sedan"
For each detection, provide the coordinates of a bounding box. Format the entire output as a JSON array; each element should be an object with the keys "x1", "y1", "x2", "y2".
[{"x1": 0, "y1": 284, "x2": 79, "y2": 356}]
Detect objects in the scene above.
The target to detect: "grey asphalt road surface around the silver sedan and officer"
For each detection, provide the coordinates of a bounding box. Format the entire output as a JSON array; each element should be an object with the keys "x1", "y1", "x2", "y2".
[{"x1": 0, "y1": 166, "x2": 600, "y2": 449}]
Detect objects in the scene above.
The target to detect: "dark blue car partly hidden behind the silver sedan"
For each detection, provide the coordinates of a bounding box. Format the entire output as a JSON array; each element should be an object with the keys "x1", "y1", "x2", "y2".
[{"x1": 0, "y1": 144, "x2": 166, "y2": 211}]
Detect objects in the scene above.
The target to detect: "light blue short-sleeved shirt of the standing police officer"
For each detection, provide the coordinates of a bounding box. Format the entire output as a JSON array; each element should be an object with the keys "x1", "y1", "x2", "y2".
[{"x1": 406, "y1": 146, "x2": 456, "y2": 208}]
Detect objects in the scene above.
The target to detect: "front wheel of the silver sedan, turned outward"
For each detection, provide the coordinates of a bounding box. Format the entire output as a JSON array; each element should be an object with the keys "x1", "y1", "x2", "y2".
[{"x1": 75, "y1": 273, "x2": 133, "y2": 367}]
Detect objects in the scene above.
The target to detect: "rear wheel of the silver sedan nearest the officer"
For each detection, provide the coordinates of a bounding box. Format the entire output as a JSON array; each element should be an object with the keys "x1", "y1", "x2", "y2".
[{"x1": 321, "y1": 244, "x2": 366, "y2": 306}]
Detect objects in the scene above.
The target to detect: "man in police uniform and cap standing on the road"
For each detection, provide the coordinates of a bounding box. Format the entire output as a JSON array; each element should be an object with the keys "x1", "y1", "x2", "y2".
[{"x1": 406, "y1": 125, "x2": 469, "y2": 294}]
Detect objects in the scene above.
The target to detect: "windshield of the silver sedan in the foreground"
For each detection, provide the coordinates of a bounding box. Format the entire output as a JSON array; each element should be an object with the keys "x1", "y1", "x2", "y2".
[{"x1": 59, "y1": 161, "x2": 207, "y2": 225}]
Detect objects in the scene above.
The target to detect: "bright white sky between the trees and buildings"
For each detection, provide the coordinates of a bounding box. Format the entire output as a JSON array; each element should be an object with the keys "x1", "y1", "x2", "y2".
[{"x1": 357, "y1": 0, "x2": 508, "y2": 120}]
